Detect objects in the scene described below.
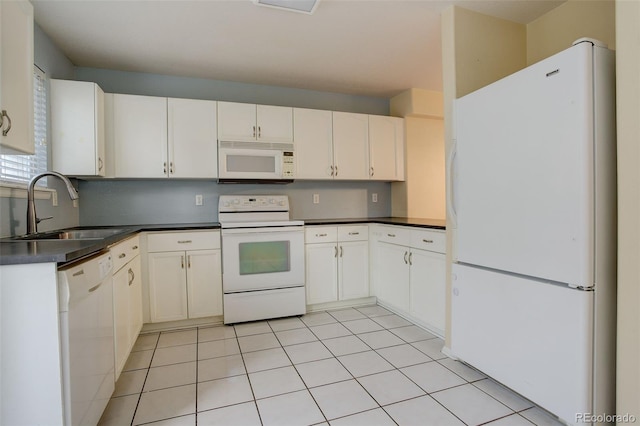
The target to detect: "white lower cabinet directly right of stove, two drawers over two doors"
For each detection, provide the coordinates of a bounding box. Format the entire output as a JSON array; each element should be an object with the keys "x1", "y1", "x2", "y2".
[{"x1": 305, "y1": 225, "x2": 369, "y2": 305}]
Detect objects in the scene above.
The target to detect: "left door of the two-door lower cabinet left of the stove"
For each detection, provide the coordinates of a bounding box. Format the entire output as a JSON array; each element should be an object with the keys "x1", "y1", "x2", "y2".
[{"x1": 148, "y1": 251, "x2": 188, "y2": 322}]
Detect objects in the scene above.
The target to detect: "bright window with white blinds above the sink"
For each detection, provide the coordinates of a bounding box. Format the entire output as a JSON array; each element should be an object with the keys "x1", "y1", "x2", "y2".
[{"x1": 0, "y1": 67, "x2": 47, "y2": 186}]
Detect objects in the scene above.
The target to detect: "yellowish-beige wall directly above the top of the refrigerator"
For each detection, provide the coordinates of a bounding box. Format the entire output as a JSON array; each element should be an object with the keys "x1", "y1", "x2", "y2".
[{"x1": 527, "y1": 0, "x2": 616, "y2": 64}]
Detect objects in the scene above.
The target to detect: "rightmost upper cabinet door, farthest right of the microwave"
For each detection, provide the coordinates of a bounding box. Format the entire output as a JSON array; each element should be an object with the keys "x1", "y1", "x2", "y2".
[{"x1": 369, "y1": 115, "x2": 404, "y2": 180}]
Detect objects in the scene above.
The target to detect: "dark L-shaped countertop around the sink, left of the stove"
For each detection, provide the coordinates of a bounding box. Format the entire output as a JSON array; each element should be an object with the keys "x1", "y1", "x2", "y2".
[{"x1": 0, "y1": 222, "x2": 220, "y2": 265}]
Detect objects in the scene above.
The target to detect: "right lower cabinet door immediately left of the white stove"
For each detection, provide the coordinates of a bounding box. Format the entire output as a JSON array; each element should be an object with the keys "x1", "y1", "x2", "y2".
[{"x1": 186, "y1": 250, "x2": 222, "y2": 318}]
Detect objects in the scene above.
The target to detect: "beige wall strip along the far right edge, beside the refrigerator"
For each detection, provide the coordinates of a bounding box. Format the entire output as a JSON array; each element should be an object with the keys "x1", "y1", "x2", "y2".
[{"x1": 616, "y1": 0, "x2": 640, "y2": 421}]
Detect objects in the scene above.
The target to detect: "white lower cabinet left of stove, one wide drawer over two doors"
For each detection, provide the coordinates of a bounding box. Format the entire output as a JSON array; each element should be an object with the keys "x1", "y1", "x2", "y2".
[{"x1": 147, "y1": 231, "x2": 222, "y2": 322}]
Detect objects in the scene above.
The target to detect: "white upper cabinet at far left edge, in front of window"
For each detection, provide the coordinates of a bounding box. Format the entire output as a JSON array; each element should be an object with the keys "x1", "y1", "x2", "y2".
[{"x1": 0, "y1": 1, "x2": 35, "y2": 154}]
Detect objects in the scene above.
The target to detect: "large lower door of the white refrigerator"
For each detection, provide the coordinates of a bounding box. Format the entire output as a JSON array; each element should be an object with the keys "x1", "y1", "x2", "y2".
[{"x1": 451, "y1": 264, "x2": 594, "y2": 424}]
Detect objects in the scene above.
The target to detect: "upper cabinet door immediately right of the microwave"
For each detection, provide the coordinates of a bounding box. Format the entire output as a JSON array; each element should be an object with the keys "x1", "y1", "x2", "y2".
[{"x1": 293, "y1": 108, "x2": 333, "y2": 179}]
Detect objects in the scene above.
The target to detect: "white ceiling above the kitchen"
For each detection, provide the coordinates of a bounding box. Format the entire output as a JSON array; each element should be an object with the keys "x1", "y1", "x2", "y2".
[{"x1": 32, "y1": 0, "x2": 565, "y2": 98}]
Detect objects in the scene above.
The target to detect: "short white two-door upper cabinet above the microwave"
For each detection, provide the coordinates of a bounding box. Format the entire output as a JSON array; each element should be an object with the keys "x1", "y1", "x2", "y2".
[{"x1": 218, "y1": 102, "x2": 293, "y2": 143}]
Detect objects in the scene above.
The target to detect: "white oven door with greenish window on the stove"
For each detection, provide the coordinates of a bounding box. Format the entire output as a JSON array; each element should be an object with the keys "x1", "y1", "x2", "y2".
[{"x1": 222, "y1": 226, "x2": 304, "y2": 293}]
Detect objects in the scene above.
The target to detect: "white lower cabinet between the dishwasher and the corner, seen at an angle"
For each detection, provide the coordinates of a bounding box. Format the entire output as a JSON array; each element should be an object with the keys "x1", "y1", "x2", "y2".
[{"x1": 110, "y1": 236, "x2": 142, "y2": 380}]
